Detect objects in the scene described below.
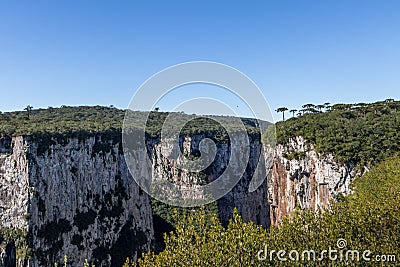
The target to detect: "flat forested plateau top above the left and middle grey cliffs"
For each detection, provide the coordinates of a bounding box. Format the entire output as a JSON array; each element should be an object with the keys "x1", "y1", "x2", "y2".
[{"x1": 0, "y1": 106, "x2": 259, "y2": 139}]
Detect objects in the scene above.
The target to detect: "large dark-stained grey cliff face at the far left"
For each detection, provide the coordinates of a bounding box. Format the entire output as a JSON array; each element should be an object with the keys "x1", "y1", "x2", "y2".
[{"x1": 0, "y1": 135, "x2": 153, "y2": 266}]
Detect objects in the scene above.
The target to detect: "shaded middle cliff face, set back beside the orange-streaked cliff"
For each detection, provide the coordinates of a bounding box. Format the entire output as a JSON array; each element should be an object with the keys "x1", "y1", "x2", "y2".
[{"x1": 152, "y1": 134, "x2": 270, "y2": 227}]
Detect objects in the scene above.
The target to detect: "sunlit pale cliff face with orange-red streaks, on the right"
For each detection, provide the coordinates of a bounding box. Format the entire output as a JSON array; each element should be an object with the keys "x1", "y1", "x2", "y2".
[{"x1": 265, "y1": 137, "x2": 357, "y2": 224}]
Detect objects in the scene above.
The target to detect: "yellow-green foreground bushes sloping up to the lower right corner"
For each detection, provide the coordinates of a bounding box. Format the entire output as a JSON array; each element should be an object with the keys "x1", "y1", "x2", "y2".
[{"x1": 129, "y1": 158, "x2": 400, "y2": 267}]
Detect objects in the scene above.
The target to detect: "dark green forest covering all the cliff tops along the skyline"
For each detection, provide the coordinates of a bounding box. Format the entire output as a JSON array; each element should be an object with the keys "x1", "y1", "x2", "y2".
[{"x1": 0, "y1": 99, "x2": 400, "y2": 171}]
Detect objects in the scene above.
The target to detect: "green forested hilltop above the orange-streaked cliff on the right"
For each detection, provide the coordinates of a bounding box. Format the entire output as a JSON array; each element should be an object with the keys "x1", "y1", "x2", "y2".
[{"x1": 277, "y1": 101, "x2": 400, "y2": 171}]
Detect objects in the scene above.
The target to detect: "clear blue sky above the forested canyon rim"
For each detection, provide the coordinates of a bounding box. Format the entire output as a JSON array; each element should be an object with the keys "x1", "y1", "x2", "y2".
[{"x1": 0, "y1": 0, "x2": 400, "y2": 122}]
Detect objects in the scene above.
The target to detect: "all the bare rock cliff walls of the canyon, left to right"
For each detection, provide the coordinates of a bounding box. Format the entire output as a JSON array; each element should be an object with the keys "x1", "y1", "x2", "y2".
[{"x1": 0, "y1": 133, "x2": 357, "y2": 267}]
